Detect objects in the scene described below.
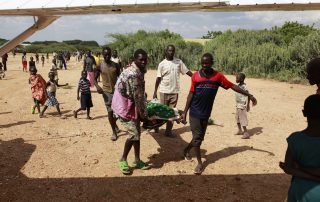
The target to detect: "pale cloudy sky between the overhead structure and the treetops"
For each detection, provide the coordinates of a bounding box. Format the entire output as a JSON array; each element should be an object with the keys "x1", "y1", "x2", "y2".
[{"x1": 0, "y1": 11, "x2": 320, "y2": 44}]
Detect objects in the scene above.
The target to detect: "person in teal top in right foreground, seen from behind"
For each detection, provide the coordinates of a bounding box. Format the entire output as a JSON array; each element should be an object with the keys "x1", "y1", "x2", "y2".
[{"x1": 279, "y1": 94, "x2": 320, "y2": 202}]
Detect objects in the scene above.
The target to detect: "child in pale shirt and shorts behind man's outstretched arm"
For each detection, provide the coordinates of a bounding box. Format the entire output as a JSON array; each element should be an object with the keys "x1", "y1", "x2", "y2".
[{"x1": 236, "y1": 73, "x2": 250, "y2": 139}]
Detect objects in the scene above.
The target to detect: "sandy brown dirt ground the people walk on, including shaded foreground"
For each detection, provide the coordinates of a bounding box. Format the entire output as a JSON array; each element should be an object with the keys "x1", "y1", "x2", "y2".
[{"x1": 0, "y1": 54, "x2": 315, "y2": 202}]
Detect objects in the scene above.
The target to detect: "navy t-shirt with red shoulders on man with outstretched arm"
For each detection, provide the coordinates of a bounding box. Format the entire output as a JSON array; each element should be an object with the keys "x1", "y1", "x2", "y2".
[{"x1": 190, "y1": 70, "x2": 234, "y2": 119}]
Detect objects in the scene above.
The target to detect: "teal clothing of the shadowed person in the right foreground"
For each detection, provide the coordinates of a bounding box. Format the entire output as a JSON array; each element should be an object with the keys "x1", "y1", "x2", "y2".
[{"x1": 287, "y1": 132, "x2": 320, "y2": 202}]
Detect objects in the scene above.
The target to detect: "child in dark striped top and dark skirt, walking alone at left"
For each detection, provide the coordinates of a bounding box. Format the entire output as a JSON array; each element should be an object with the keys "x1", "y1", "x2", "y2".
[{"x1": 73, "y1": 70, "x2": 93, "y2": 120}]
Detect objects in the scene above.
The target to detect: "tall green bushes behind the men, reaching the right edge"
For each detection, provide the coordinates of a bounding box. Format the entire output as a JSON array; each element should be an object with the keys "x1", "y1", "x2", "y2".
[{"x1": 109, "y1": 22, "x2": 320, "y2": 83}]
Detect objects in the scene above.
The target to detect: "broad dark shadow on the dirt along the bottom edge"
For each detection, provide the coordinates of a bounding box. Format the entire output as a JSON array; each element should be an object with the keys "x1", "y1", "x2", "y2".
[{"x1": 0, "y1": 138, "x2": 290, "y2": 202}]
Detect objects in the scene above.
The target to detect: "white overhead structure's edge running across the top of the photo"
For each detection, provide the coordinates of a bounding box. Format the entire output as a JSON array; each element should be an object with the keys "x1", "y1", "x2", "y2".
[{"x1": 0, "y1": 0, "x2": 320, "y2": 16}]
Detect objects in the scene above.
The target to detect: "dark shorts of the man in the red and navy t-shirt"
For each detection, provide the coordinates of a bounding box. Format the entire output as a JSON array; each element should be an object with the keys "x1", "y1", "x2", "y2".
[{"x1": 189, "y1": 116, "x2": 208, "y2": 147}]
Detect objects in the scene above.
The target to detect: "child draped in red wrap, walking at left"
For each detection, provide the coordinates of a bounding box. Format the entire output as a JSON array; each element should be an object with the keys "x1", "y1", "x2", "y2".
[{"x1": 29, "y1": 66, "x2": 47, "y2": 115}]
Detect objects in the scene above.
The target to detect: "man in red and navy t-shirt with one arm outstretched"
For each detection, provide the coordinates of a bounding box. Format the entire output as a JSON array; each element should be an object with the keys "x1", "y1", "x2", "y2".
[{"x1": 182, "y1": 53, "x2": 257, "y2": 174}]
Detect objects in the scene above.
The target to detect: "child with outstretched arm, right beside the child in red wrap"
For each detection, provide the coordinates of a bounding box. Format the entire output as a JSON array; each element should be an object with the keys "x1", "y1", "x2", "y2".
[{"x1": 40, "y1": 72, "x2": 68, "y2": 118}]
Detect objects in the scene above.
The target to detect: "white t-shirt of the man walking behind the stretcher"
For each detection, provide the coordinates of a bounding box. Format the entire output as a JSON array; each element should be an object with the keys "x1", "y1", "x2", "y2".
[{"x1": 157, "y1": 58, "x2": 189, "y2": 94}]
